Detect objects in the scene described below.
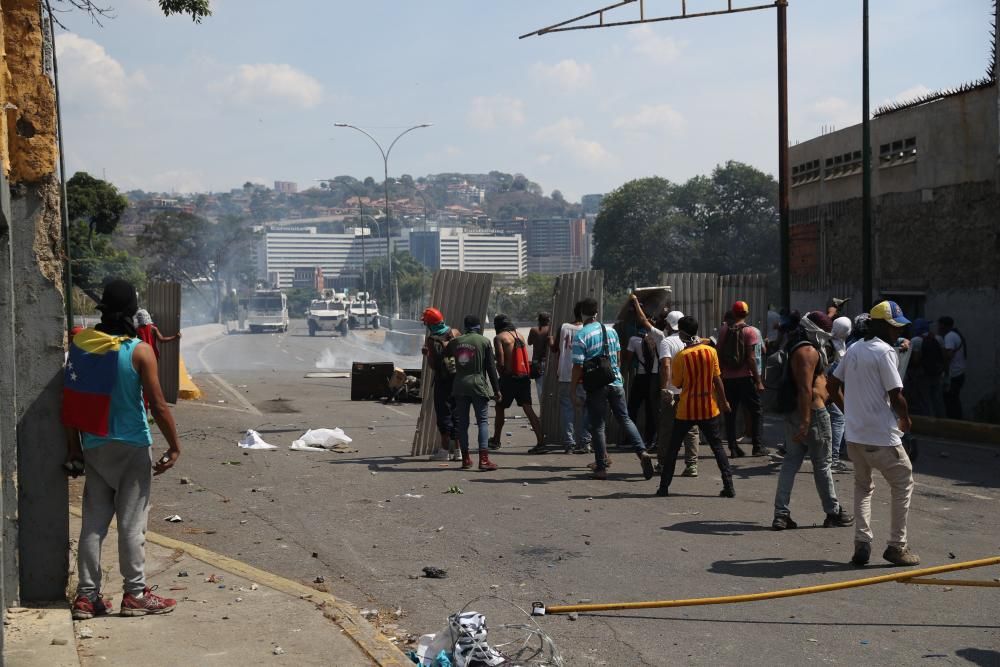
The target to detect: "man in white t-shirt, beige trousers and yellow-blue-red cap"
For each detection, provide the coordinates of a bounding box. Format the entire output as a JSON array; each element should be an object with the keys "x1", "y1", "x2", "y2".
[{"x1": 830, "y1": 301, "x2": 920, "y2": 566}]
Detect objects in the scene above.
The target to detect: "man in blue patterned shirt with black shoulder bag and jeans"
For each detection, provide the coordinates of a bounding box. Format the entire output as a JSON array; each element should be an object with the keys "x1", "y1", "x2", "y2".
[{"x1": 572, "y1": 297, "x2": 653, "y2": 479}]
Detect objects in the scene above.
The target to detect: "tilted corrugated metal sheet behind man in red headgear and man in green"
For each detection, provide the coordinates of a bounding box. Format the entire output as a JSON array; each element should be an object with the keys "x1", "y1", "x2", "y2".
[{"x1": 410, "y1": 269, "x2": 493, "y2": 456}]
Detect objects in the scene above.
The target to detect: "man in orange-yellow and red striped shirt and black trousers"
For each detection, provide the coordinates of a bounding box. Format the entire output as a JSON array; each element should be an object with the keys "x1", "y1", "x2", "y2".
[{"x1": 656, "y1": 317, "x2": 736, "y2": 498}]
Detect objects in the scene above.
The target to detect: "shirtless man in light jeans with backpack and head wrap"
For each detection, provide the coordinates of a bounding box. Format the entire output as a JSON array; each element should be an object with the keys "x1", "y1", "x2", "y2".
[{"x1": 771, "y1": 311, "x2": 854, "y2": 530}]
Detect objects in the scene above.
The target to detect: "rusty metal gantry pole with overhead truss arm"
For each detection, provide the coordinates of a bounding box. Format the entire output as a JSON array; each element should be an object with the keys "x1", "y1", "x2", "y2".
[{"x1": 519, "y1": 0, "x2": 791, "y2": 308}]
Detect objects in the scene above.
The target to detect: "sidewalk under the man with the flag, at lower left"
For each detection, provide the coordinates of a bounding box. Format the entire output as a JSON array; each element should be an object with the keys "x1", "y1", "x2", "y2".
[{"x1": 5, "y1": 513, "x2": 412, "y2": 667}]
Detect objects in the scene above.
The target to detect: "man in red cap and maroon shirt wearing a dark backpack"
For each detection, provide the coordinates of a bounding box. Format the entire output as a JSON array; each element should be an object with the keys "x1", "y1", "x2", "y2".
[{"x1": 718, "y1": 301, "x2": 767, "y2": 458}]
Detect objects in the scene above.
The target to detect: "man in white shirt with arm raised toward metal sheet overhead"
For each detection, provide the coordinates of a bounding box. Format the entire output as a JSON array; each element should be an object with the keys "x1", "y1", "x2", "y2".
[{"x1": 622, "y1": 294, "x2": 666, "y2": 449}]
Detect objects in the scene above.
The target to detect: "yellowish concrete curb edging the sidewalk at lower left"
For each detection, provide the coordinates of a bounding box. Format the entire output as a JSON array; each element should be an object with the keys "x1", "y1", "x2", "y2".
[{"x1": 69, "y1": 505, "x2": 413, "y2": 667}]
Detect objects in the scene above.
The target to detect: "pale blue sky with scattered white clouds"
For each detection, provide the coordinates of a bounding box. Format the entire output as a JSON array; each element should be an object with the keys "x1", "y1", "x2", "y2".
[{"x1": 56, "y1": 0, "x2": 992, "y2": 200}]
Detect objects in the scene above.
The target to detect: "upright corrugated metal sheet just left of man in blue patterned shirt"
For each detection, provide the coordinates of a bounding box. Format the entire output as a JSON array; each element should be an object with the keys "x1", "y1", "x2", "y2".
[{"x1": 541, "y1": 271, "x2": 604, "y2": 445}]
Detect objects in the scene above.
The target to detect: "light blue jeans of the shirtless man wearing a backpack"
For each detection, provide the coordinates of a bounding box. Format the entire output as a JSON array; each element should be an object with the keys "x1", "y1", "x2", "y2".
[{"x1": 774, "y1": 408, "x2": 840, "y2": 517}]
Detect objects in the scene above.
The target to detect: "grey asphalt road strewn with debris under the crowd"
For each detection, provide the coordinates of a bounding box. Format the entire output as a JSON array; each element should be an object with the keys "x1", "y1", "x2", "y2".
[{"x1": 158, "y1": 332, "x2": 1000, "y2": 665}]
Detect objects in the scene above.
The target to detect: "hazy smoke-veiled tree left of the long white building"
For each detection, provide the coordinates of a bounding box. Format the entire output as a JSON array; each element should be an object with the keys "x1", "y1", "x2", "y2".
[{"x1": 137, "y1": 211, "x2": 254, "y2": 321}]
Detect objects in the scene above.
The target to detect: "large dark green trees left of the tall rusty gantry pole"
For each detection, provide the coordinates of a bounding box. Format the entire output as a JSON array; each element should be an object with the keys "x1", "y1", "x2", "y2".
[{"x1": 593, "y1": 162, "x2": 780, "y2": 291}]
